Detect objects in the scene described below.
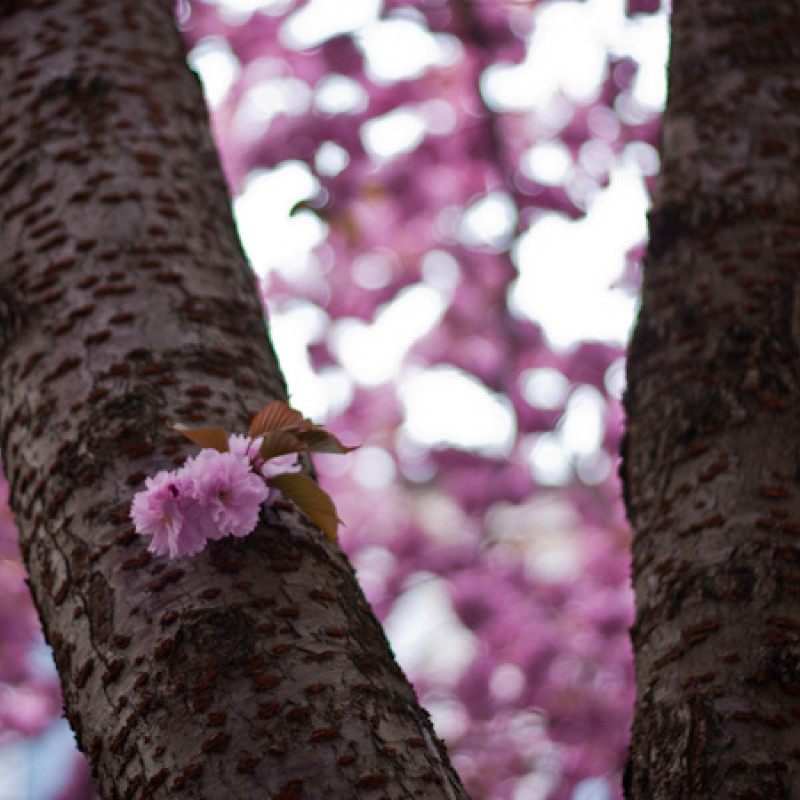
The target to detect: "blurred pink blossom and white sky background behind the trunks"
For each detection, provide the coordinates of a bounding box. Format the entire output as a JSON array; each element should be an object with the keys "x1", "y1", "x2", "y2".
[{"x1": 0, "y1": 0, "x2": 668, "y2": 800}]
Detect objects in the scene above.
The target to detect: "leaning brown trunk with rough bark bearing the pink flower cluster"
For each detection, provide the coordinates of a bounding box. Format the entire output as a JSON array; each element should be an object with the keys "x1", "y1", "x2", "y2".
[{"x1": 0, "y1": 0, "x2": 466, "y2": 800}]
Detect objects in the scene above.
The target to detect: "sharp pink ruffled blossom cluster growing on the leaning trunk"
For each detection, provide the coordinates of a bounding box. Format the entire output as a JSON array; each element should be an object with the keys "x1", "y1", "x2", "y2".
[{"x1": 131, "y1": 436, "x2": 270, "y2": 558}]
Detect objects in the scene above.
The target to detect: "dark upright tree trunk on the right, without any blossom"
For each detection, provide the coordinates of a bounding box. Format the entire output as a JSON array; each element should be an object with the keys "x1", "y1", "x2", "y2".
[{"x1": 624, "y1": 0, "x2": 800, "y2": 800}]
